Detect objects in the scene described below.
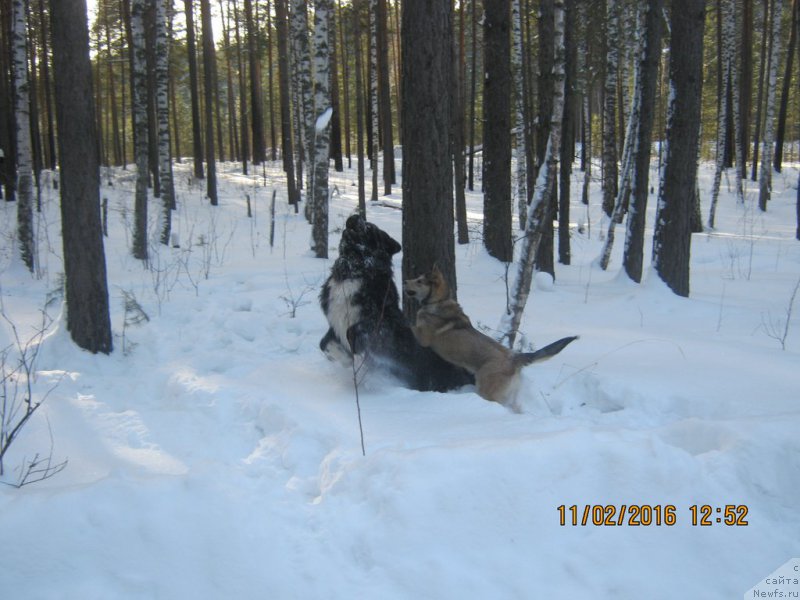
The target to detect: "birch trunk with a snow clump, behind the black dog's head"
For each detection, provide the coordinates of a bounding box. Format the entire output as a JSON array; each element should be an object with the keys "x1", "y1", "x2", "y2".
[{"x1": 310, "y1": 0, "x2": 333, "y2": 258}]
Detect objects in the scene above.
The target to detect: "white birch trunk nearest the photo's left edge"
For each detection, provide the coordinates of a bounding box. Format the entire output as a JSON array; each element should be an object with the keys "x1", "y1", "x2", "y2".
[{"x1": 12, "y1": 0, "x2": 36, "y2": 273}]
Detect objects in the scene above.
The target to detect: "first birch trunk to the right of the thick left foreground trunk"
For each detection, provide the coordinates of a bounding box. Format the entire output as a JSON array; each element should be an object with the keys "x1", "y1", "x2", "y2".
[{"x1": 131, "y1": 0, "x2": 149, "y2": 260}]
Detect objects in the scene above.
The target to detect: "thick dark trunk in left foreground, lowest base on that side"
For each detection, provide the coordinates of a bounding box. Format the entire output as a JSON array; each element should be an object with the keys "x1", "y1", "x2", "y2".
[{"x1": 50, "y1": 0, "x2": 113, "y2": 354}]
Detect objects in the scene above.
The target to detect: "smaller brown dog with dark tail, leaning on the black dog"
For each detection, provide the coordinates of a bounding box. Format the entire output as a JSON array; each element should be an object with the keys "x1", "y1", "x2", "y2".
[{"x1": 403, "y1": 267, "x2": 577, "y2": 409}]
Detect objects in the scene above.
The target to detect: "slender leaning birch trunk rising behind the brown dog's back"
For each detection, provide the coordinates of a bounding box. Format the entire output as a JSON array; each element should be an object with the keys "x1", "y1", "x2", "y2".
[{"x1": 502, "y1": 0, "x2": 565, "y2": 348}]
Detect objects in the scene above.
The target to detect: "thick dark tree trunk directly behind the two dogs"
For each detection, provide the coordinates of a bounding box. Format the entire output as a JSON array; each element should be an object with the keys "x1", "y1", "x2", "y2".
[{"x1": 400, "y1": 0, "x2": 456, "y2": 312}]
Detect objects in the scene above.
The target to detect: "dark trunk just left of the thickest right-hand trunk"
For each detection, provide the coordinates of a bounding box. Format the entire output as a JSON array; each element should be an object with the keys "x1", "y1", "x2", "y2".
[{"x1": 622, "y1": 0, "x2": 664, "y2": 283}]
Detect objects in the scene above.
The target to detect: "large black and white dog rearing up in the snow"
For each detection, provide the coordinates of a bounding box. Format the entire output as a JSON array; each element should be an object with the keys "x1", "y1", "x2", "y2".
[{"x1": 319, "y1": 215, "x2": 475, "y2": 391}]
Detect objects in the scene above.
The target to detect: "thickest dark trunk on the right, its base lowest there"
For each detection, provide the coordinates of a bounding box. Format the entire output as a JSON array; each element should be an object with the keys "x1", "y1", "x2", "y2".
[{"x1": 653, "y1": 0, "x2": 706, "y2": 297}]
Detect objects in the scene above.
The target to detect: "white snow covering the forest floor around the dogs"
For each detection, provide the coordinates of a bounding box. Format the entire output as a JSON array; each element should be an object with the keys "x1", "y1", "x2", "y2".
[{"x1": 0, "y1": 157, "x2": 800, "y2": 599}]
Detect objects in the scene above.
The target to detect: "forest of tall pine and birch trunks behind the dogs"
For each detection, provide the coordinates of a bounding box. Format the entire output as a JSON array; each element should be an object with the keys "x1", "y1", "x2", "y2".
[{"x1": 0, "y1": 0, "x2": 800, "y2": 349}]
